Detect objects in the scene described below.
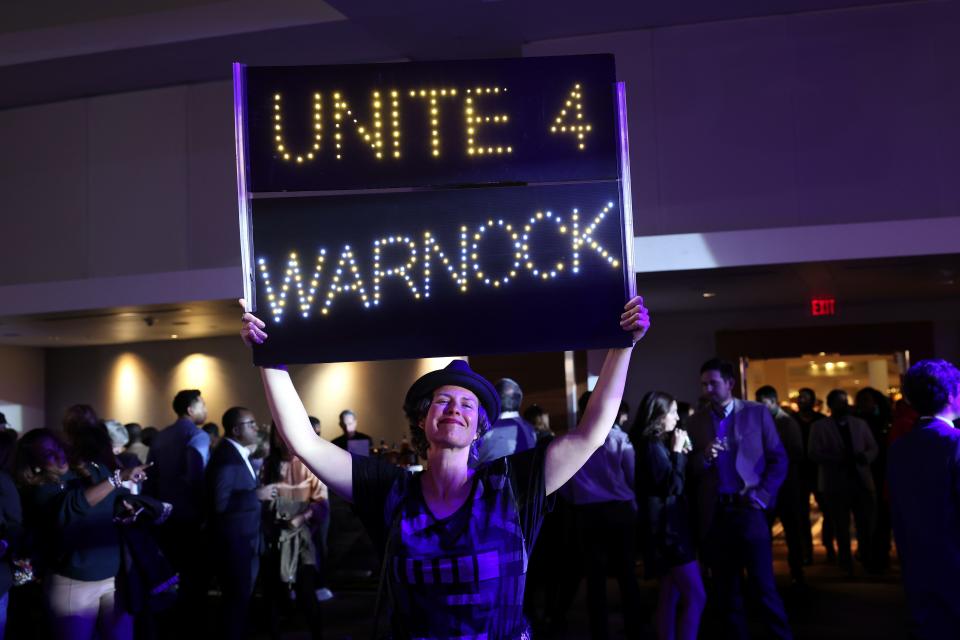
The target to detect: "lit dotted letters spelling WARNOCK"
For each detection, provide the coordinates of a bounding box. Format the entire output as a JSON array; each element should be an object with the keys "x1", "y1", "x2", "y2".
[{"x1": 257, "y1": 201, "x2": 621, "y2": 323}]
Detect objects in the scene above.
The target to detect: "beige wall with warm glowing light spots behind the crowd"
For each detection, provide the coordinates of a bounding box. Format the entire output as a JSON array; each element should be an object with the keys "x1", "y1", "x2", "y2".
[{"x1": 46, "y1": 336, "x2": 460, "y2": 443}]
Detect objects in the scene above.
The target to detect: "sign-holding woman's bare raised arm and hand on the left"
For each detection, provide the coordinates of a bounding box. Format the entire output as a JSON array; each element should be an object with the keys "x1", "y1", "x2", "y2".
[{"x1": 240, "y1": 299, "x2": 353, "y2": 502}]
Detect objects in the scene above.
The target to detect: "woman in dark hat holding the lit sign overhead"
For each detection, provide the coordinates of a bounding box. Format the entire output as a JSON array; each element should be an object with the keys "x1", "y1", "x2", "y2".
[{"x1": 241, "y1": 297, "x2": 650, "y2": 640}]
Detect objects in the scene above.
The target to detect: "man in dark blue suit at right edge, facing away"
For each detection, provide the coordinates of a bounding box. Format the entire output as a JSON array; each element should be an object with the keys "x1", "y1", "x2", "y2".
[{"x1": 887, "y1": 360, "x2": 960, "y2": 640}]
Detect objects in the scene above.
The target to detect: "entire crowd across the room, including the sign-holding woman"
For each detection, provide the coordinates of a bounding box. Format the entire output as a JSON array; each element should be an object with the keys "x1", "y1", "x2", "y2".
[{"x1": 0, "y1": 302, "x2": 960, "y2": 640}]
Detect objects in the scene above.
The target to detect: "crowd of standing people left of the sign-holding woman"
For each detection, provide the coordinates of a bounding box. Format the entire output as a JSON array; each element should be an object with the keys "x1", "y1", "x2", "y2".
[{"x1": 0, "y1": 390, "x2": 332, "y2": 639}]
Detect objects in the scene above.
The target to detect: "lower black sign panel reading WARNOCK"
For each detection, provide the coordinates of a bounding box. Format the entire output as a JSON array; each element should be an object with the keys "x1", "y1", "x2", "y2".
[{"x1": 252, "y1": 180, "x2": 632, "y2": 364}]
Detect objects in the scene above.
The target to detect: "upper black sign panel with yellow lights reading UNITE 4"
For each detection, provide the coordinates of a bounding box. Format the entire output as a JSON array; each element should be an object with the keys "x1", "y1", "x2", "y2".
[{"x1": 244, "y1": 56, "x2": 618, "y2": 193}]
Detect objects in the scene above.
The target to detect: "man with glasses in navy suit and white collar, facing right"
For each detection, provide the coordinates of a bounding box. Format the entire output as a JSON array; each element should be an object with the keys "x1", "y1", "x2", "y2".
[{"x1": 206, "y1": 407, "x2": 276, "y2": 639}]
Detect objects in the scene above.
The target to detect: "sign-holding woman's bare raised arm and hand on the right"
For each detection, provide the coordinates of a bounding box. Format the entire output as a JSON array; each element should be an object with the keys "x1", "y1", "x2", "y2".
[{"x1": 544, "y1": 296, "x2": 650, "y2": 495}]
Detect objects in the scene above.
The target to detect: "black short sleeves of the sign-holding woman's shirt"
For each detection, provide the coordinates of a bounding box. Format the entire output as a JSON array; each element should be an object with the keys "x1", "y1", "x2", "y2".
[{"x1": 353, "y1": 441, "x2": 554, "y2": 553}]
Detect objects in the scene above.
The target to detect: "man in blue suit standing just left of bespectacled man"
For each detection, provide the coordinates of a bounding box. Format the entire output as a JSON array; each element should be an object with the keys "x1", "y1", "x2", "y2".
[{"x1": 143, "y1": 389, "x2": 210, "y2": 635}]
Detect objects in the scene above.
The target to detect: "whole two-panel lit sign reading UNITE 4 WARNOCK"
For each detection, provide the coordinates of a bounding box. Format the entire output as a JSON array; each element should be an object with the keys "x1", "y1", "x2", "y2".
[{"x1": 235, "y1": 56, "x2": 633, "y2": 364}]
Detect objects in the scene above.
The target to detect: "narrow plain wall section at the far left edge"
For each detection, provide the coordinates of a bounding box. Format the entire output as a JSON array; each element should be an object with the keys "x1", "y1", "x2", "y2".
[{"x1": 0, "y1": 347, "x2": 44, "y2": 431}]
